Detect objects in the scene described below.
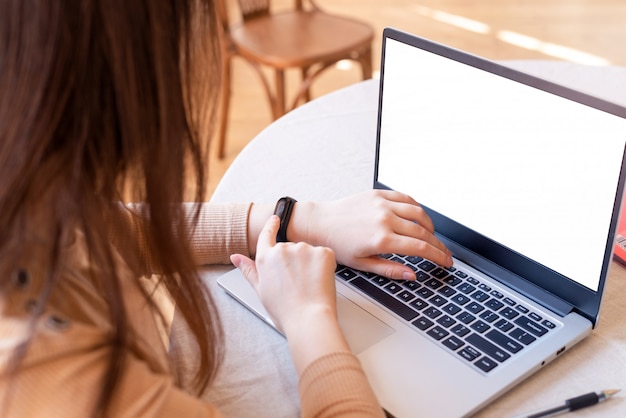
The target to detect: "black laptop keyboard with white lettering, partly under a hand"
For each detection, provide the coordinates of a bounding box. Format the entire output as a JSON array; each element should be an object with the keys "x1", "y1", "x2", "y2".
[{"x1": 336, "y1": 254, "x2": 557, "y2": 373}]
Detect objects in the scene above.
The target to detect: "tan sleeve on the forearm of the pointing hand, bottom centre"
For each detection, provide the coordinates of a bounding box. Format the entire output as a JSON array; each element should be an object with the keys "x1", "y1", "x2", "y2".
[{"x1": 298, "y1": 352, "x2": 385, "y2": 418}]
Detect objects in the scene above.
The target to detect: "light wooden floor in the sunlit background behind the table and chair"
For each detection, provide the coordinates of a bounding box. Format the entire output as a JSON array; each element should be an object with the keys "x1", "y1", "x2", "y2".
[{"x1": 209, "y1": 0, "x2": 626, "y2": 196}]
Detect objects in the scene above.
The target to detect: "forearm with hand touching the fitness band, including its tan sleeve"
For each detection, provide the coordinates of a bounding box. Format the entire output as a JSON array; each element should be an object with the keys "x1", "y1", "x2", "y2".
[{"x1": 231, "y1": 215, "x2": 383, "y2": 417}]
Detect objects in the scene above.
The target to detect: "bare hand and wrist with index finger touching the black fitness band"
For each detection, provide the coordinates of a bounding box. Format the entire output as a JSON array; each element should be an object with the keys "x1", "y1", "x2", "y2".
[{"x1": 231, "y1": 215, "x2": 349, "y2": 368}]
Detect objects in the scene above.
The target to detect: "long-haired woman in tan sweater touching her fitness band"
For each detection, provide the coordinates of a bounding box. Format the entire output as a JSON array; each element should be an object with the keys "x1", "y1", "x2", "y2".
[{"x1": 0, "y1": 0, "x2": 451, "y2": 417}]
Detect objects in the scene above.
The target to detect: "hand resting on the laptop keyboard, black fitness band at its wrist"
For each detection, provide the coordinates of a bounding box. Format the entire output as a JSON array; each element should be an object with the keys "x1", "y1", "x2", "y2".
[{"x1": 290, "y1": 190, "x2": 452, "y2": 280}]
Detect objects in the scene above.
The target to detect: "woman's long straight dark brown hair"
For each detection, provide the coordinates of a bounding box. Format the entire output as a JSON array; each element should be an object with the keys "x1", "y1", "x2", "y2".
[{"x1": 0, "y1": 0, "x2": 221, "y2": 415}]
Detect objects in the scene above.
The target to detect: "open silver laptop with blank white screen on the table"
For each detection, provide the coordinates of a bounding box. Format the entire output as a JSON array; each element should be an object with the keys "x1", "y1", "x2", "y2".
[{"x1": 219, "y1": 28, "x2": 626, "y2": 417}]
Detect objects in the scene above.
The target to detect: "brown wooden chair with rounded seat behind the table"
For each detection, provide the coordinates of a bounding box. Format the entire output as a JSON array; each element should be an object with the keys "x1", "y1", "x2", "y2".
[{"x1": 218, "y1": 0, "x2": 374, "y2": 158}]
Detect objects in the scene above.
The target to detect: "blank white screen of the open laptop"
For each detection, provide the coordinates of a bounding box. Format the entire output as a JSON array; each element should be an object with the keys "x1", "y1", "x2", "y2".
[{"x1": 378, "y1": 39, "x2": 626, "y2": 291}]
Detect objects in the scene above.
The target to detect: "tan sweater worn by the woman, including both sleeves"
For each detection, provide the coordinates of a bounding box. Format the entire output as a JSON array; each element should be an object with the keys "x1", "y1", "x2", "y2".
[{"x1": 0, "y1": 204, "x2": 382, "y2": 418}]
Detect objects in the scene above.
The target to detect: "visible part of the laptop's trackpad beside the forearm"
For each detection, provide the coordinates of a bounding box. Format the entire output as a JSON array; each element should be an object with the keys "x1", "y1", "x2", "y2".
[{"x1": 337, "y1": 293, "x2": 395, "y2": 354}]
